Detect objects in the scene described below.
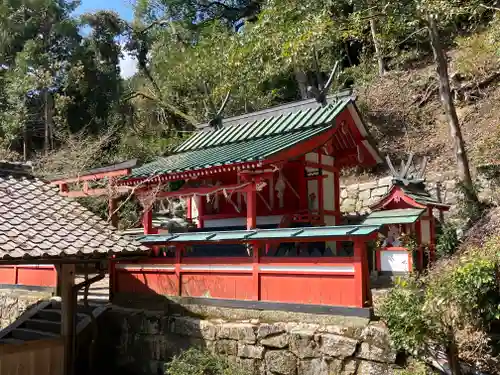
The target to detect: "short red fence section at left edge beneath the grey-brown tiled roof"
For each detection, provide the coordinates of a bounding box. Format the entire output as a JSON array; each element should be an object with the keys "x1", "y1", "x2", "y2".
[{"x1": 0, "y1": 264, "x2": 57, "y2": 287}]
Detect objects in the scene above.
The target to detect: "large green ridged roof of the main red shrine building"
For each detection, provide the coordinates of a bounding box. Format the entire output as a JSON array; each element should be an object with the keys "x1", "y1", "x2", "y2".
[{"x1": 126, "y1": 97, "x2": 352, "y2": 179}]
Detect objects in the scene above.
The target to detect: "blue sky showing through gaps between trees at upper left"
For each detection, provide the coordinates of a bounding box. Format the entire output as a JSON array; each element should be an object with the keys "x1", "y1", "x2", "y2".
[{"x1": 75, "y1": 0, "x2": 137, "y2": 78}]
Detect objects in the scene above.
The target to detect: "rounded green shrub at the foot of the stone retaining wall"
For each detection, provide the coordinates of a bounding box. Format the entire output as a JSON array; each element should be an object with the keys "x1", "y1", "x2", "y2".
[{"x1": 165, "y1": 348, "x2": 249, "y2": 375}]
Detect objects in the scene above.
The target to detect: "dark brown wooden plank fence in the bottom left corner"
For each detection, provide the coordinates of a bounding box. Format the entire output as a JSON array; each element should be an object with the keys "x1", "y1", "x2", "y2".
[{"x1": 0, "y1": 338, "x2": 64, "y2": 375}]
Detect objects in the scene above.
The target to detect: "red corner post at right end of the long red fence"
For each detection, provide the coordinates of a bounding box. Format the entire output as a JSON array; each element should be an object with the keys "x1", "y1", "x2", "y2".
[{"x1": 353, "y1": 239, "x2": 371, "y2": 307}]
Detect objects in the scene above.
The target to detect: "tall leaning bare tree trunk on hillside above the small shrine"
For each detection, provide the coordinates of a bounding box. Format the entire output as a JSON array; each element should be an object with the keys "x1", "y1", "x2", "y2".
[{"x1": 428, "y1": 15, "x2": 479, "y2": 204}]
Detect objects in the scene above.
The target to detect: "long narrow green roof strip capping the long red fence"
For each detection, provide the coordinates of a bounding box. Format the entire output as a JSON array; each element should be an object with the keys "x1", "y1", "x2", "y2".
[{"x1": 136, "y1": 225, "x2": 380, "y2": 244}]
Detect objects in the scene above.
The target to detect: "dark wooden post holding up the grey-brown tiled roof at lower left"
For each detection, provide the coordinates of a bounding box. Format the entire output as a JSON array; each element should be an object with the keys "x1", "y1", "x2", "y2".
[{"x1": 58, "y1": 264, "x2": 76, "y2": 375}]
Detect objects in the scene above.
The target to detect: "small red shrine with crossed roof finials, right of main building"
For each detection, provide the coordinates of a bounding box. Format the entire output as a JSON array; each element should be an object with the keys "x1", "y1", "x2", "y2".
[{"x1": 363, "y1": 154, "x2": 449, "y2": 275}]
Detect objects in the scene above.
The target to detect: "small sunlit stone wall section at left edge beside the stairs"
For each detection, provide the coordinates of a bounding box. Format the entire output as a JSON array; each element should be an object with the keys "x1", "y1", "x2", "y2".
[{"x1": 0, "y1": 289, "x2": 51, "y2": 329}]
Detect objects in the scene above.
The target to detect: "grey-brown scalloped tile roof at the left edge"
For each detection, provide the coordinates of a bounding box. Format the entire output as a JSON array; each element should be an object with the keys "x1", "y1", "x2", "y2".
[{"x1": 0, "y1": 170, "x2": 148, "y2": 261}]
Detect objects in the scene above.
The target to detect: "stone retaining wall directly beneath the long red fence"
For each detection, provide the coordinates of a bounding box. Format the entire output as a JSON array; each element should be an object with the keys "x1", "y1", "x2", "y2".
[{"x1": 99, "y1": 308, "x2": 396, "y2": 375}]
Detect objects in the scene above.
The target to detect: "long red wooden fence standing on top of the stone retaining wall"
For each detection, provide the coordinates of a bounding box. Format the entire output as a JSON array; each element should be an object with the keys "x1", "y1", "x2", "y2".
[{"x1": 111, "y1": 247, "x2": 369, "y2": 307}]
